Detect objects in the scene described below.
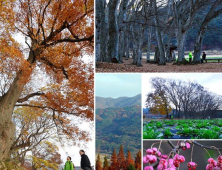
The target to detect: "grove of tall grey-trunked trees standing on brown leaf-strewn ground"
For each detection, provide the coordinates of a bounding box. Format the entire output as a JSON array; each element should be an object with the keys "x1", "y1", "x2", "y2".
[{"x1": 96, "y1": 0, "x2": 222, "y2": 66}]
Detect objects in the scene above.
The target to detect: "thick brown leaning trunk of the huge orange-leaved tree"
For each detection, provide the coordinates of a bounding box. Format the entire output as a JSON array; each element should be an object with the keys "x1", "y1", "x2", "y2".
[{"x1": 0, "y1": 52, "x2": 34, "y2": 161}]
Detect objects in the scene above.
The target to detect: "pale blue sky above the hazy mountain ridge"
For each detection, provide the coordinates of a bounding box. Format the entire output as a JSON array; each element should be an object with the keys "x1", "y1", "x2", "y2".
[{"x1": 95, "y1": 73, "x2": 141, "y2": 98}]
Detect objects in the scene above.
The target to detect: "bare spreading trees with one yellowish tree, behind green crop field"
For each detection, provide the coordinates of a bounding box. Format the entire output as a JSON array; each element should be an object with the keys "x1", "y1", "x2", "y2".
[{"x1": 146, "y1": 77, "x2": 222, "y2": 118}]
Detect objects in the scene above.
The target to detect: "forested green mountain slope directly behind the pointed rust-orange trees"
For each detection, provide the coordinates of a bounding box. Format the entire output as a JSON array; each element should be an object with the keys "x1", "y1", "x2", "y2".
[{"x1": 96, "y1": 104, "x2": 141, "y2": 156}]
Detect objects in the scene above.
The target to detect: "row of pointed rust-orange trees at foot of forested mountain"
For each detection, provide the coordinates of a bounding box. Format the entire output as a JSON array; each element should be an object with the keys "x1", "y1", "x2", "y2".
[{"x1": 96, "y1": 145, "x2": 141, "y2": 170}]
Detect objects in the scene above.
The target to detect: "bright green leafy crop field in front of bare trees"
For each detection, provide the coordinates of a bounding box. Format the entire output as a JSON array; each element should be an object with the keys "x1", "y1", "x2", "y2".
[{"x1": 143, "y1": 119, "x2": 222, "y2": 139}]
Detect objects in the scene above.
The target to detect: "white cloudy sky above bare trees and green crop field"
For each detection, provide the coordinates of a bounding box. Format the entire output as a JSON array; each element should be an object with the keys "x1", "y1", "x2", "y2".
[{"x1": 142, "y1": 73, "x2": 222, "y2": 107}]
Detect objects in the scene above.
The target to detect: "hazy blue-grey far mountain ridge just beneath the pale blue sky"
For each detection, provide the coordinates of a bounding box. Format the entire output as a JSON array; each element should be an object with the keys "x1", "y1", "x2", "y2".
[{"x1": 96, "y1": 94, "x2": 141, "y2": 109}]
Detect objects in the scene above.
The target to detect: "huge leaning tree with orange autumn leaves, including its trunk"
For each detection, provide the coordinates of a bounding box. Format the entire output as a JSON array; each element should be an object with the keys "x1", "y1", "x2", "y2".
[{"x1": 0, "y1": 0, "x2": 94, "y2": 161}]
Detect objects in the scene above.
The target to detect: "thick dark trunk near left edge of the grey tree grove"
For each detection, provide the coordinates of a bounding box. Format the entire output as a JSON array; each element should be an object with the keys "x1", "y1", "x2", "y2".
[{"x1": 107, "y1": 0, "x2": 119, "y2": 63}]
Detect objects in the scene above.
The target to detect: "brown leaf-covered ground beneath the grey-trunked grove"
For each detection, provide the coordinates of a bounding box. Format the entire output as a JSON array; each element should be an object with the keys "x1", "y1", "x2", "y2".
[{"x1": 96, "y1": 59, "x2": 222, "y2": 72}]
